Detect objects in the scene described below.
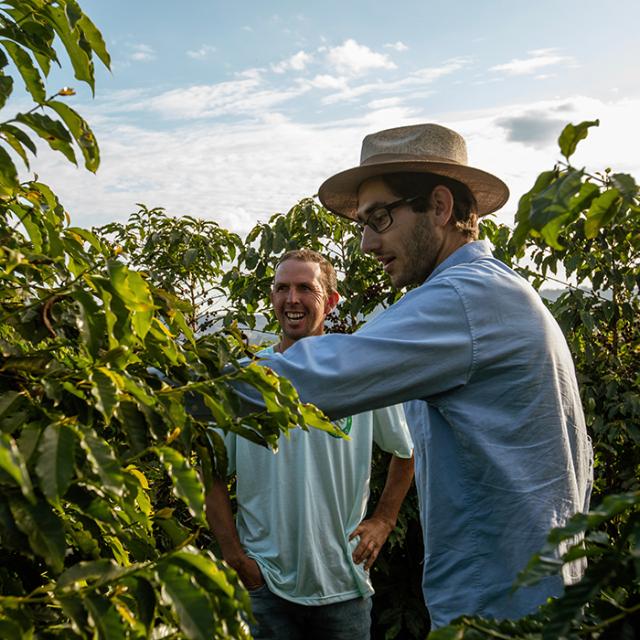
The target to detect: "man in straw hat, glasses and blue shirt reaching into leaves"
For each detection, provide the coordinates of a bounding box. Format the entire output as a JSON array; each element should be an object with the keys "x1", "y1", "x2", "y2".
[{"x1": 236, "y1": 124, "x2": 592, "y2": 628}]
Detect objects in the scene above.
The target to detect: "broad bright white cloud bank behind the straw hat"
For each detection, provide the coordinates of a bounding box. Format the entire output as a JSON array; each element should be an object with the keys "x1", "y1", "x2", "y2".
[{"x1": 26, "y1": 82, "x2": 640, "y2": 238}]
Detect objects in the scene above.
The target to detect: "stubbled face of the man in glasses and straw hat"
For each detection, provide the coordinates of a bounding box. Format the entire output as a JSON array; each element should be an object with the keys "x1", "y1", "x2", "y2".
[{"x1": 358, "y1": 178, "x2": 446, "y2": 288}]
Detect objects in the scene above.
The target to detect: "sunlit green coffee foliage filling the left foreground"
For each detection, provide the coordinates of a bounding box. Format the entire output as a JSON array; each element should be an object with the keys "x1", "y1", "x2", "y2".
[{"x1": 0, "y1": 0, "x2": 338, "y2": 639}]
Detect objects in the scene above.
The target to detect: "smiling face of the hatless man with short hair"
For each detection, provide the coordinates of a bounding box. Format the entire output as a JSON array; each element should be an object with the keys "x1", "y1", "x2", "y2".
[{"x1": 271, "y1": 259, "x2": 338, "y2": 350}]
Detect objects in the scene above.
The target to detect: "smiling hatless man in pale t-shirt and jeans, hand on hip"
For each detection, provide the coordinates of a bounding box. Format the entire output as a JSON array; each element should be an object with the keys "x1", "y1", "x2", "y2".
[{"x1": 207, "y1": 249, "x2": 413, "y2": 640}]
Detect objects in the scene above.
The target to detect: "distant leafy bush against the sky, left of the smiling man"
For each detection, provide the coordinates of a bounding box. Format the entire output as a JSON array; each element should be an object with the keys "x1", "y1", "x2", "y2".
[{"x1": 96, "y1": 205, "x2": 243, "y2": 331}]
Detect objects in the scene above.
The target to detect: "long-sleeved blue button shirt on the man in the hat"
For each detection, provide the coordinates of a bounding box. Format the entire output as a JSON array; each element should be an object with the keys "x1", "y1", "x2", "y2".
[{"x1": 248, "y1": 241, "x2": 592, "y2": 627}]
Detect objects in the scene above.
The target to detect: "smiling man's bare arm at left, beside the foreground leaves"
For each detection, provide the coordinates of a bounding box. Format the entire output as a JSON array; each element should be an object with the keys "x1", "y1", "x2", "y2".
[{"x1": 205, "y1": 477, "x2": 264, "y2": 590}]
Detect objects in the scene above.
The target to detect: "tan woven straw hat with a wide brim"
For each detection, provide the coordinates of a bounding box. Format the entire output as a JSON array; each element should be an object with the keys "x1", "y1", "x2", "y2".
[{"x1": 318, "y1": 124, "x2": 509, "y2": 219}]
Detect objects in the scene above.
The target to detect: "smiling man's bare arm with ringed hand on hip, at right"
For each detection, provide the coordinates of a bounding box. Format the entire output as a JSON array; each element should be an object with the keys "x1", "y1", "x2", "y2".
[{"x1": 349, "y1": 456, "x2": 413, "y2": 570}]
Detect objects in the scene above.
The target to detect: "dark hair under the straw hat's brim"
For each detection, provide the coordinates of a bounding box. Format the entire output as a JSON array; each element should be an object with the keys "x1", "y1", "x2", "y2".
[{"x1": 380, "y1": 172, "x2": 478, "y2": 240}]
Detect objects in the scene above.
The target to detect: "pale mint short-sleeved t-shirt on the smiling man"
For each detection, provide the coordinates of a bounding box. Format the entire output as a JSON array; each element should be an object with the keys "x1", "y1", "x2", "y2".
[{"x1": 230, "y1": 351, "x2": 413, "y2": 606}]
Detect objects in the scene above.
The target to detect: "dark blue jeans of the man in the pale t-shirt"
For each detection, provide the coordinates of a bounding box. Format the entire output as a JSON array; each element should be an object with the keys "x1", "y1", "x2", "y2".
[{"x1": 249, "y1": 585, "x2": 371, "y2": 640}]
